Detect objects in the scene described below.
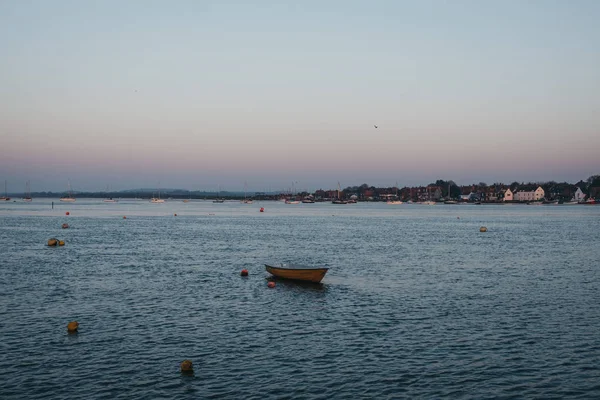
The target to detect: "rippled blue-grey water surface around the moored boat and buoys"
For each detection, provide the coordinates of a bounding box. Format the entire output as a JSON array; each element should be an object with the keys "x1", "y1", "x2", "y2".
[{"x1": 0, "y1": 199, "x2": 600, "y2": 399}]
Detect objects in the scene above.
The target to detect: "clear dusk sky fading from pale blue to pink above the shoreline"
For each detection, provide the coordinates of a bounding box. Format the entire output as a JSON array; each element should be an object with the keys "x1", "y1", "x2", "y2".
[{"x1": 0, "y1": 0, "x2": 600, "y2": 192}]
